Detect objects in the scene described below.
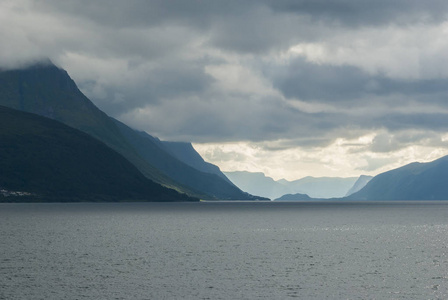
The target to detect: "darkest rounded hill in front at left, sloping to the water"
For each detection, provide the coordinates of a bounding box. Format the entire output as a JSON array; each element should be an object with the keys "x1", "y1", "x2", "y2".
[{"x1": 0, "y1": 106, "x2": 198, "y2": 202}]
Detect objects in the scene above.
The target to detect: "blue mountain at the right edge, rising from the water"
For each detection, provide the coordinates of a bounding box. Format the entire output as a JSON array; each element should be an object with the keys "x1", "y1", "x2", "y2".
[{"x1": 346, "y1": 156, "x2": 448, "y2": 200}]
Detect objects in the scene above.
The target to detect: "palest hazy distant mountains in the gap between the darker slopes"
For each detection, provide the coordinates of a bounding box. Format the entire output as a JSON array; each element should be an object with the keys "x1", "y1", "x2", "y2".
[{"x1": 224, "y1": 171, "x2": 357, "y2": 199}]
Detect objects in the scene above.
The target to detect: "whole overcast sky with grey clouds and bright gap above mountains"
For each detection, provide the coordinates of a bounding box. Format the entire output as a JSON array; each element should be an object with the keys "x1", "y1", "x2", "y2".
[{"x1": 0, "y1": 0, "x2": 448, "y2": 180}]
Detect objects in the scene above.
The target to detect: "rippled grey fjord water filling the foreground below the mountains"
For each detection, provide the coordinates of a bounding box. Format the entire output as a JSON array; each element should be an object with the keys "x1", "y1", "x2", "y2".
[{"x1": 0, "y1": 202, "x2": 448, "y2": 299}]
